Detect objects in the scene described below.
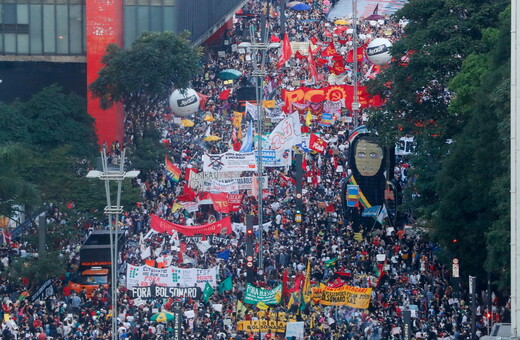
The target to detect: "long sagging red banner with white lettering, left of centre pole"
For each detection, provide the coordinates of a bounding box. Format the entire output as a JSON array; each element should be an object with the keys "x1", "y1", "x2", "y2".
[{"x1": 150, "y1": 215, "x2": 231, "y2": 236}]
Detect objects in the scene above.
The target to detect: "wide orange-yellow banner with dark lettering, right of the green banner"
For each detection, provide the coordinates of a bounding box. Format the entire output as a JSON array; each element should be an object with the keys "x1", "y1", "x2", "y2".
[{"x1": 312, "y1": 284, "x2": 372, "y2": 309}]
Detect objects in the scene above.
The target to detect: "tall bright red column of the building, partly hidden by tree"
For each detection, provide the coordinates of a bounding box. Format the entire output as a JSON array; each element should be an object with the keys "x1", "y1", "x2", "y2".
[{"x1": 85, "y1": 0, "x2": 124, "y2": 145}]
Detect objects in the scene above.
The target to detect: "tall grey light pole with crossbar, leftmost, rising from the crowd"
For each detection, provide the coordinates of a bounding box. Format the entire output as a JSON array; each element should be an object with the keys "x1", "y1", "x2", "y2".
[{"x1": 87, "y1": 147, "x2": 139, "y2": 340}]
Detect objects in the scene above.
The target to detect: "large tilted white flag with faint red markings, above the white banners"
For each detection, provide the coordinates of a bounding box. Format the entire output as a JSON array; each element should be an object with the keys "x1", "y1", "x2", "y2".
[{"x1": 268, "y1": 112, "x2": 302, "y2": 151}]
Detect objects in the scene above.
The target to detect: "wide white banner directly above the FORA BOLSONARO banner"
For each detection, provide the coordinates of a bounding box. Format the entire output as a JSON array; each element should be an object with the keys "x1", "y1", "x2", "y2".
[{"x1": 126, "y1": 265, "x2": 217, "y2": 289}]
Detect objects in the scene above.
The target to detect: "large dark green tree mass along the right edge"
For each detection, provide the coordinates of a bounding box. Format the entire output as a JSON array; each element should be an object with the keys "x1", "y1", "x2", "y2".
[{"x1": 368, "y1": 0, "x2": 510, "y2": 287}]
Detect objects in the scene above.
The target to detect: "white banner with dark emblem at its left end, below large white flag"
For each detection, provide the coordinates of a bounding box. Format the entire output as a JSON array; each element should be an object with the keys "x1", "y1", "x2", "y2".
[{"x1": 202, "y1": 151, "x2": 256, "y2": 172}]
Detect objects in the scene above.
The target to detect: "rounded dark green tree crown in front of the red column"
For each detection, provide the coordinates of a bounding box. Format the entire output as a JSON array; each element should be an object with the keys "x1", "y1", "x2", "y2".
[{"x1": 90, "y1": 32, "x2": 201, "y2": 123}]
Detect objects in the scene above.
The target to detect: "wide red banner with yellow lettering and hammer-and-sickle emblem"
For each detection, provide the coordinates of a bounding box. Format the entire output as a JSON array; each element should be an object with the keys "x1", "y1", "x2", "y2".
[{"x1": 282, "y1": 85, "x2": 383, "y2": 112}]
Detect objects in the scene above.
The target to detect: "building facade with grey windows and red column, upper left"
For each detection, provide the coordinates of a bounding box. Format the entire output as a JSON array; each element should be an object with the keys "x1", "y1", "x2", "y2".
[{"x1": 0, "y1": 0, "x2": 247, "y2": 143}]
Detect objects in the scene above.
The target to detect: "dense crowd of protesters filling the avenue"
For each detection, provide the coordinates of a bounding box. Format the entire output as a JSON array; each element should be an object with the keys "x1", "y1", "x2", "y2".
[{"x1": 0, "y1": 0, "x2": 508, "y2": 340}]
